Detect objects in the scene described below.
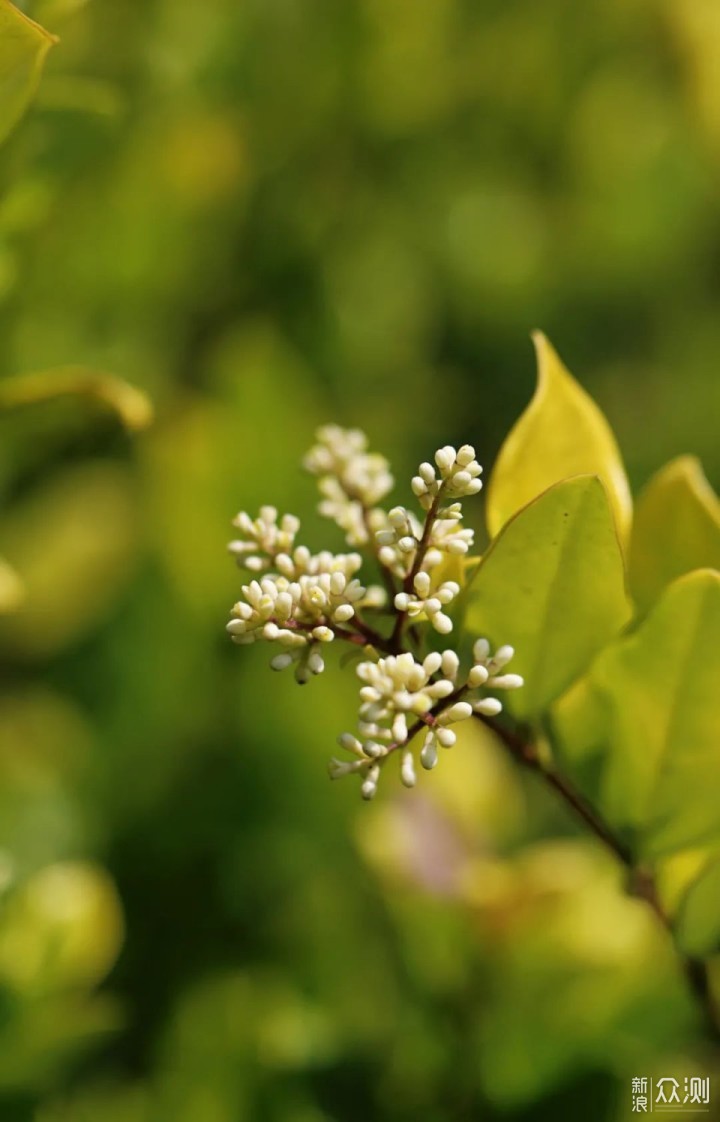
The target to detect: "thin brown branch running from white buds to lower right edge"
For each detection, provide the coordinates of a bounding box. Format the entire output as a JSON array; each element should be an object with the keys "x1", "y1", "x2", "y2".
[{"x1": 478, "y1": 715, "x2": 720, "y2": 1043}]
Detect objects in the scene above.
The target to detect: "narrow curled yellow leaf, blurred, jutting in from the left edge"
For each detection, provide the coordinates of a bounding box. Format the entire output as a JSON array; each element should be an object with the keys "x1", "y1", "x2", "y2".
[{"x1": 0, "y1": 367, "x2": 153, "y2": 432}]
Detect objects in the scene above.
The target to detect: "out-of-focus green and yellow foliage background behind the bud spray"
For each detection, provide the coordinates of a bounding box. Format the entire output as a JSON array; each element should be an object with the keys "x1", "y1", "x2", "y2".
[{"x1": 0, "y1": 0, "x2": 720, "y2": 1122}]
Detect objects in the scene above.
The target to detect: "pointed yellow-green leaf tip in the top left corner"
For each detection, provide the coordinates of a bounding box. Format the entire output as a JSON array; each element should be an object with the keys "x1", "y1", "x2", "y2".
[{"x1": 0, "y1": 0, "x2": 57, "y2": 141}]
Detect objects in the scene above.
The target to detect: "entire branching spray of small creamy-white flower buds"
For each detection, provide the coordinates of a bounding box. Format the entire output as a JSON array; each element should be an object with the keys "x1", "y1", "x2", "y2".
[{"x1": 228, "y1": 425, "x2": 523, "y2": 799}]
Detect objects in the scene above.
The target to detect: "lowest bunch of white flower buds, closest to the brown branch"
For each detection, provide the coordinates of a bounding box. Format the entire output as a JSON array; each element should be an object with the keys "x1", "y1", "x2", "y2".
[{"x1": 329, "y1": 638, "x2": 523, "y2": 799}]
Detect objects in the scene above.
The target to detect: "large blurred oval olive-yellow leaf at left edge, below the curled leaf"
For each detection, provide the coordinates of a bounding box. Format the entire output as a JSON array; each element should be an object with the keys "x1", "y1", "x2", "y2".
[{"x1": 0, "y1": 463, "x2": 137, "y2": 659}]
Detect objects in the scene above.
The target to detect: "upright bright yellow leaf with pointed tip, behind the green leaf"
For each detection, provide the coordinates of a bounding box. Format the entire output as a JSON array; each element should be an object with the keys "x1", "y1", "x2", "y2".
[{"x1": 487, "y1": 331, "x2": 633, "y2": 542}]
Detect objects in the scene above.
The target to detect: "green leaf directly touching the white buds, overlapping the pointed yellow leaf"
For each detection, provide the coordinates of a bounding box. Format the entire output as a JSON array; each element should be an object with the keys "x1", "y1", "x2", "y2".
[{"x1": 465, "y1": 476, "x2": 629, "y2": 717}]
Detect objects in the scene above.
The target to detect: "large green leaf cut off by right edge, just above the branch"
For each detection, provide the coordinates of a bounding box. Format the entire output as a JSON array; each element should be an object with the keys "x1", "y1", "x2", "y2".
[{"x1": 591, "y1": 569, "x2": 720, "y2": 856}]
